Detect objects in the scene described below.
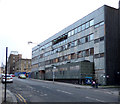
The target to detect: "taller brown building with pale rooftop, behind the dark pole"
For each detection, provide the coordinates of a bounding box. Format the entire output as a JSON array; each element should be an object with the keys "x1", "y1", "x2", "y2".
[{"x1": 7, "y1": 51, "x2": 22, "y2": 74}]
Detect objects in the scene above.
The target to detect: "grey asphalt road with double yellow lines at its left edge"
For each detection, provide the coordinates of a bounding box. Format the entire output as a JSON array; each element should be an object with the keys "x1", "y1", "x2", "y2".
[{"x1": 7, "y1": 78, "x2": 118, "y2": 104}]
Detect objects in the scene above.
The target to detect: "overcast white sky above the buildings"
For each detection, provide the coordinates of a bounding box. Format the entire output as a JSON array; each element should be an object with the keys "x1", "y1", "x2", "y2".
[{"x1": 0, "y1": 0, "x2": 119, "y2": 64}]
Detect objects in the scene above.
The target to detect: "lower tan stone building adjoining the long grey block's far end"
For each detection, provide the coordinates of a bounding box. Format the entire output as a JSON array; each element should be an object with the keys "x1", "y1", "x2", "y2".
[{"x1": 15, "y1": 58, "x2": 31, "y2": 73}]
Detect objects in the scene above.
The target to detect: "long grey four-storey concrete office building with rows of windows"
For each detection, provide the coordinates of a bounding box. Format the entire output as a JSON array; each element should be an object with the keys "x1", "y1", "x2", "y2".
[{"x1": 32, "y1": 5, "x2": 120, "y2": 85}]
